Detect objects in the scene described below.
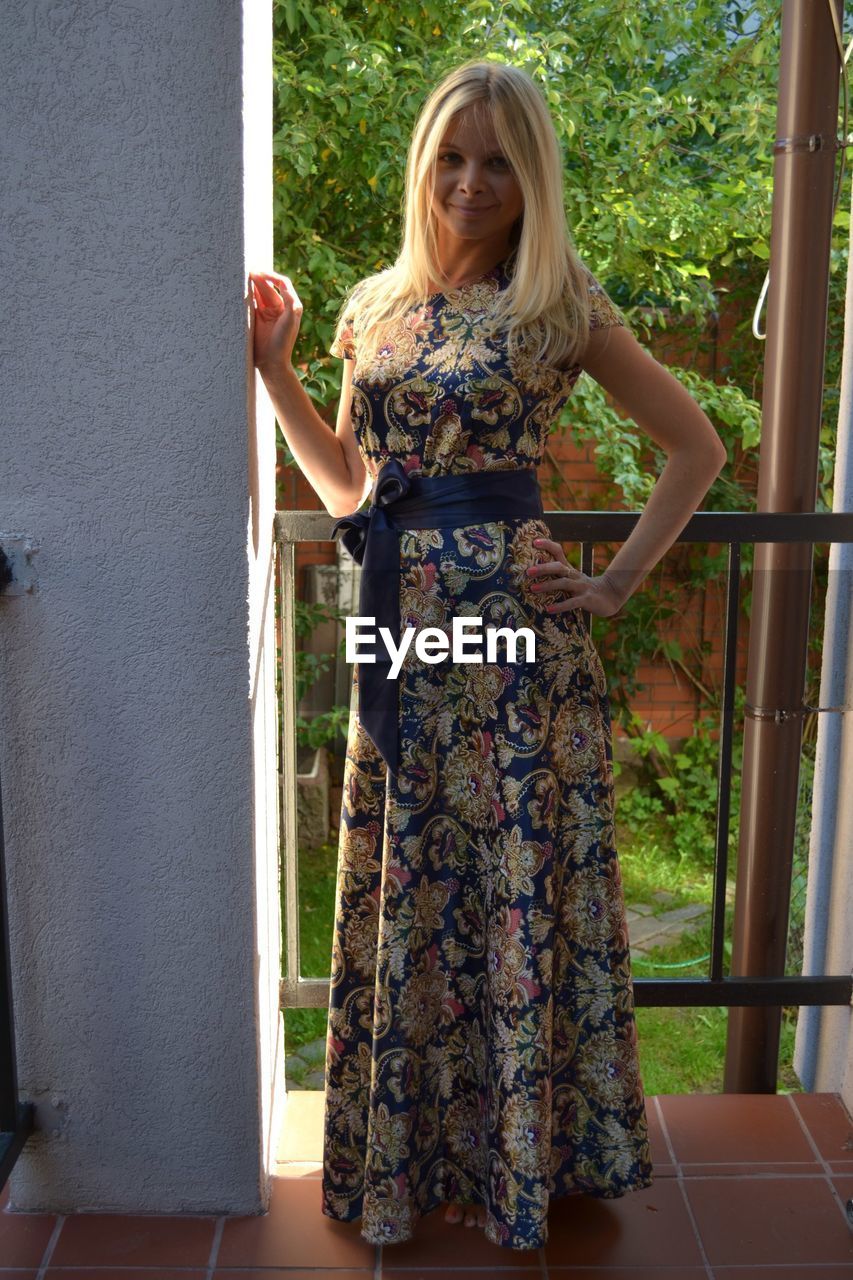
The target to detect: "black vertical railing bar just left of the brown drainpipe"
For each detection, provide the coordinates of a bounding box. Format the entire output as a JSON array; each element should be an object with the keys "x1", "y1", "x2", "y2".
[{"x1": 708, "y1": 543, "x2": 740, "y2": 982}]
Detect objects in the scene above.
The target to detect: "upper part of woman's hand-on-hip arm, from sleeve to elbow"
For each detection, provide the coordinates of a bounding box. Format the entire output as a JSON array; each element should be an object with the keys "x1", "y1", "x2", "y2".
[{"x1": 580, "y1": 325, "x2": 725, "y2": 458}]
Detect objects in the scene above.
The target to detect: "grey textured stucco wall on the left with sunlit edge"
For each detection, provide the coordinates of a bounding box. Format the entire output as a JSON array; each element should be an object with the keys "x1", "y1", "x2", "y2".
[{"x1": 0, "y1": 0, "x2": 282, "y2": 1212}]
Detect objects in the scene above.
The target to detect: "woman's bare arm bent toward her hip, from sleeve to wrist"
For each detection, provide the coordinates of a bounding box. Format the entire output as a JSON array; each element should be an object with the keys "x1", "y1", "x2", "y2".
[{"x1": 581, "y1": 325, "x2": 726, "y2": 608}]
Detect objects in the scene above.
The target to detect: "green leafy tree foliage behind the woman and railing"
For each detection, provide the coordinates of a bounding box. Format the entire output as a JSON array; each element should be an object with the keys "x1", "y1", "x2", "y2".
[{"x1": 274, "y1": 0, "x2": 849, "y2": 742}]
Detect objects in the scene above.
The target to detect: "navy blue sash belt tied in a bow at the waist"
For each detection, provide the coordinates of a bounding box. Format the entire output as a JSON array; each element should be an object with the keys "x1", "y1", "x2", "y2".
[{"x1": 332, "y1": 458, "x2": 544, "y2": 773}]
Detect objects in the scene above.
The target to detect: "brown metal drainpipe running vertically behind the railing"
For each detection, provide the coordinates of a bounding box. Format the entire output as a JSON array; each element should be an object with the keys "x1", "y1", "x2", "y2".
[{"x1": 724, "y1": 0, "x2": 844, "y2": 1093}]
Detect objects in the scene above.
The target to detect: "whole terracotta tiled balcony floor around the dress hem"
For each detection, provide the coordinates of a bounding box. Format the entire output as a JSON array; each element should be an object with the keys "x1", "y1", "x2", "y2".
[{"x1": 0, "y1": 1092, "x2": 853, "y2": 1280}]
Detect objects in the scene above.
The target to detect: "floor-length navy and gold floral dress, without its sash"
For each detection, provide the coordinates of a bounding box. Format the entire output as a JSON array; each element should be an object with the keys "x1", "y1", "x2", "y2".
[{"x1": 323, "y1": 260, "x2": 653, "y2": 1249}]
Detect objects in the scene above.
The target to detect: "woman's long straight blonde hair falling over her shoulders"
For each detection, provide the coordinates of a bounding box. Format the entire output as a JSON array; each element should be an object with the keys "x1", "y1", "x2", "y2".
[{"x1": 334, "y1": 59, "x2": 604, "y2": 367}]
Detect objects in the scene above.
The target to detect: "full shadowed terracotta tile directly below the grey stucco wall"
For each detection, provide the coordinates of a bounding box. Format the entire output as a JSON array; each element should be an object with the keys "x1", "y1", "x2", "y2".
[{"x1": 50, "y1": 1213, "x2": 216, "y2": 1268}]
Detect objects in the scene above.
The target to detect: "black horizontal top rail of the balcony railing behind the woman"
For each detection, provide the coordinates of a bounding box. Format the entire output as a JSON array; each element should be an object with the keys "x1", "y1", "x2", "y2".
[{"x1": 274, "y1": 511, "x2": 853, "y2": 544}]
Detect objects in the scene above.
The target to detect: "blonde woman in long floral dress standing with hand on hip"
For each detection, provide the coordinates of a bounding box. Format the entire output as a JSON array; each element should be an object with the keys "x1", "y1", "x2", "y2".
[{"x1": 251, "y1": 61, "x2": 725, "y2": 1249}]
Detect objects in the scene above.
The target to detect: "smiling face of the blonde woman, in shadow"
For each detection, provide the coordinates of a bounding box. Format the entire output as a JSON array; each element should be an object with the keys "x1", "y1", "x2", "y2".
[{"x1": 432, "y1": 109, "x2": 524, "y2": 248}]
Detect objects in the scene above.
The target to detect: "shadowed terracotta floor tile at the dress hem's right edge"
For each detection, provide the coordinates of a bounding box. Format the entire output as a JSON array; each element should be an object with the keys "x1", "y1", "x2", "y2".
[{"x1": 544, "y1": 1178, "x2": 702, "y2": 1276}]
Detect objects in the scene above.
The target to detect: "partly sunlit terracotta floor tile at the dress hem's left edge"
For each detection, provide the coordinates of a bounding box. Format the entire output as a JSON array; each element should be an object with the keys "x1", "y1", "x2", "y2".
[{"x1": 216, "y1": 1178, "x2": 377, "y2": 1270}]
